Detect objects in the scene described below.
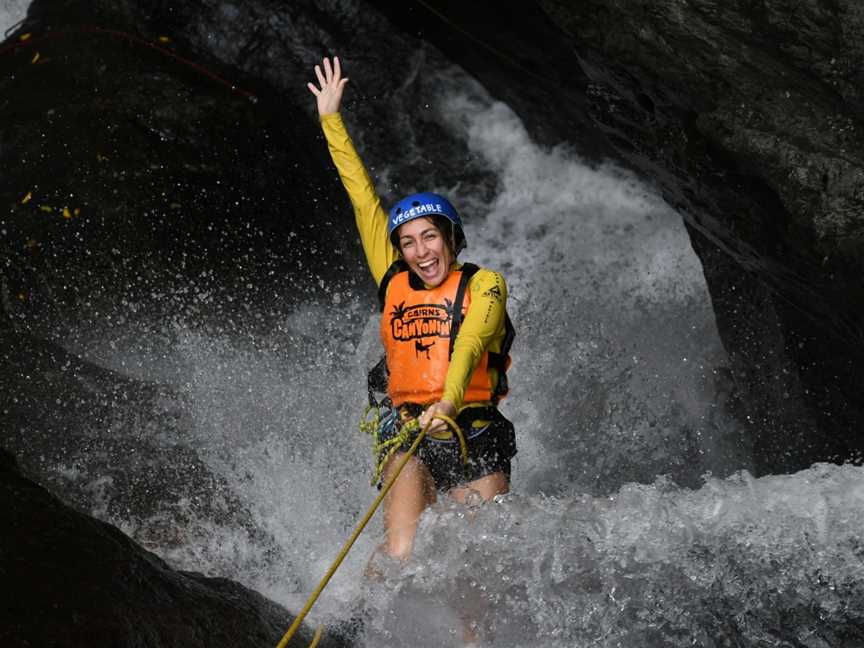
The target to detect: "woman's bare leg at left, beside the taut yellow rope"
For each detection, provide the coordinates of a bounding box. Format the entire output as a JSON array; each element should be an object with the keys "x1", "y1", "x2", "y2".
[{"x1": 384, "y1": 452, "x2": 435, "y2": 560}]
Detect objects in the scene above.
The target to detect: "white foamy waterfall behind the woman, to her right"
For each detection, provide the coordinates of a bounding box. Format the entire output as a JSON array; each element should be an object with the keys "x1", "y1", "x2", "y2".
[{"x1": 428, "y1": 69, "x2": 750, "y2": 493}]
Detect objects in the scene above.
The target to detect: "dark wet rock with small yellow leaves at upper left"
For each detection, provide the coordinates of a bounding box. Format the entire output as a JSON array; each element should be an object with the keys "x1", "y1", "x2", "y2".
[{"x1": 0, "y1": 1, "x2": 362, "y2": 335}]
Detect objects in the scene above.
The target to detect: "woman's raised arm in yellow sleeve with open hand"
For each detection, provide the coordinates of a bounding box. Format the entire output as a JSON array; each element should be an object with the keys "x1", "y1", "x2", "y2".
[{"x1": 307, "y1": 57, "x2": 397, "y2": 285}]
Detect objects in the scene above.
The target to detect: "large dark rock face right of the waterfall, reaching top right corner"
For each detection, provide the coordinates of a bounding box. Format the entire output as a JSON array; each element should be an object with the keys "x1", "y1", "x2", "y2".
[{"x1": 375, "y1": 0, "x2": 864, "y2": 472}]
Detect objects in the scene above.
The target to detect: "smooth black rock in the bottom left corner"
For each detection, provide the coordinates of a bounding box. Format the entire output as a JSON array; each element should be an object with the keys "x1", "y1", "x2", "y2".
[{"x1": 0, "y1": 450, "x2": 345, "y2": 648}]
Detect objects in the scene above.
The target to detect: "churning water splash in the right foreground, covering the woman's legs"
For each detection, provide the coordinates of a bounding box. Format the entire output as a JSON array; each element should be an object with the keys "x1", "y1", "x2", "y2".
[{"x1": 352, "y1": 465, "x2": 864, "y2": 648}]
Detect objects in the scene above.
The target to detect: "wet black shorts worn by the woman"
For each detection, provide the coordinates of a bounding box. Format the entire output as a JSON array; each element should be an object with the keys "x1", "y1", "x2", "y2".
[{"x1": 379, "y1": 404, "x2": 516, "y2": 490}]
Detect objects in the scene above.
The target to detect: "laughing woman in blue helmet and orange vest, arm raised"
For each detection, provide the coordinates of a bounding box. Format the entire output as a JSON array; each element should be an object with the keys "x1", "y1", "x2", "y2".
[{"x1": 308, "y1": 58, "x2": 516, "y2": 560}]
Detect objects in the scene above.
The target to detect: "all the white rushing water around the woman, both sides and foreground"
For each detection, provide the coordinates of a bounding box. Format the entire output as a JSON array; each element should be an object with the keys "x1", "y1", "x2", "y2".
[{"x1": 28, "y1": 48, "x2": 864, "y2": 647}]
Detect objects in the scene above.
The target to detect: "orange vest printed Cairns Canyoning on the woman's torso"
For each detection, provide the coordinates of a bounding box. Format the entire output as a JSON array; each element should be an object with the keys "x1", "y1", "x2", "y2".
[{"x1": 381, "y1": 269, "x2": 506, "y2": 407}]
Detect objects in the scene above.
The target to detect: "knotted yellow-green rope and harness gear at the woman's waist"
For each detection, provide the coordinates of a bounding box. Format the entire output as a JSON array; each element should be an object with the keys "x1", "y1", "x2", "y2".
[{"x1": 360, "y1": 405, "x2": 468, "y2": 486}]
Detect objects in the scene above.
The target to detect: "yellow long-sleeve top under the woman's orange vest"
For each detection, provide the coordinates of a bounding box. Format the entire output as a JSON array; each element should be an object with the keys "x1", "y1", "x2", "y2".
[{"x1": 321, "y1": 113, "x2": 507, "y2": 410}]
